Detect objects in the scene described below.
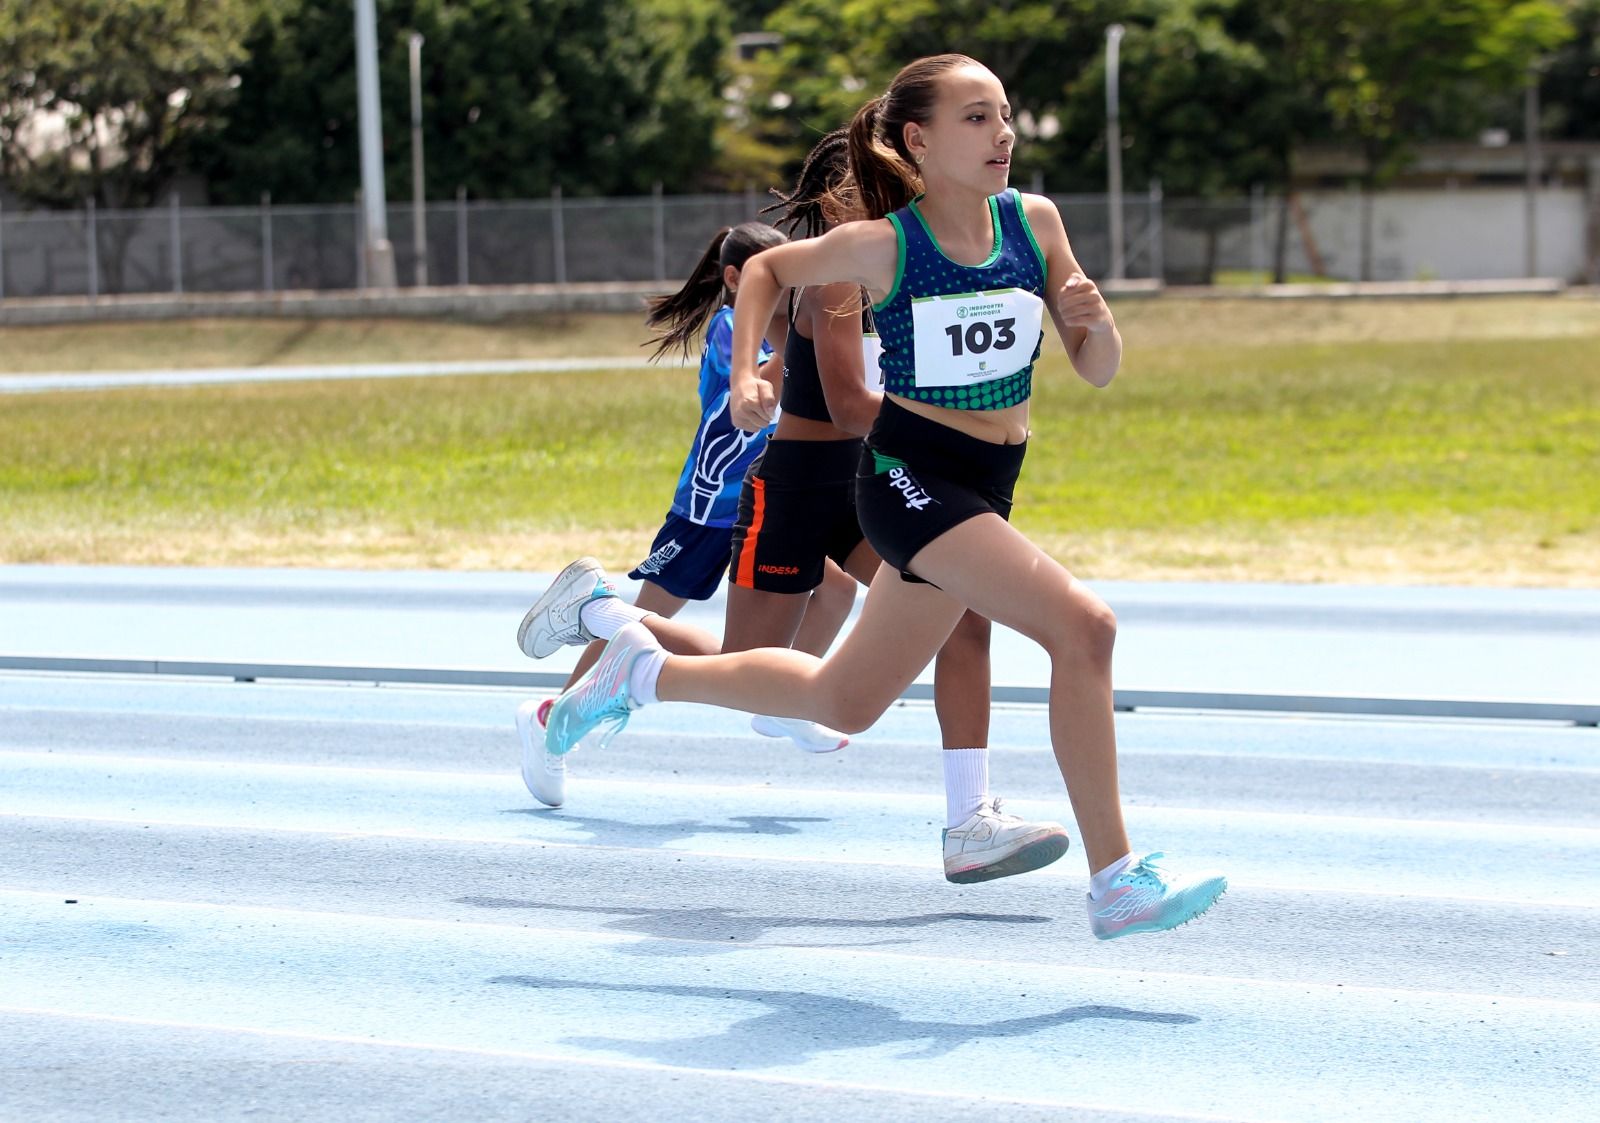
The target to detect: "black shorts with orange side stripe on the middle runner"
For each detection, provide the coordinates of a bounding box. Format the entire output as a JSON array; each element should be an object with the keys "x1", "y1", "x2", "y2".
[{"x1": 728, "y1": 438, "x2": 862, "y2": 593}]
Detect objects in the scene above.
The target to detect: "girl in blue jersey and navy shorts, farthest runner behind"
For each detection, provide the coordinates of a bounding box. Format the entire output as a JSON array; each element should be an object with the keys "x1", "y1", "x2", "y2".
[{"x1": 517, "y1": 222, "x2": 856, "y2": 806}]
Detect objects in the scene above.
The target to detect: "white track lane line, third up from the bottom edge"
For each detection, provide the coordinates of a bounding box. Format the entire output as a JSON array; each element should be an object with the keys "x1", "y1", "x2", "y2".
[{"x1": 0, "y1": 811, "x2": 1600, "y2": 912}]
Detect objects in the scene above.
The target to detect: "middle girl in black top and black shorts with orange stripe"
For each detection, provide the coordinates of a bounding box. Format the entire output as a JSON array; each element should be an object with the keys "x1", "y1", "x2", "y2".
[{"x1": 524, "y1": 130, "x2": 1067, "y2": 883}]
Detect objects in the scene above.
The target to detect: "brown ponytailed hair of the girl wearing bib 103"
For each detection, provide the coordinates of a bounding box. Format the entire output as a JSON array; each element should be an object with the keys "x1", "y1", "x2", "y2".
[{"x1": 850, "y1": 54, "x2": 982, "y2": 218}]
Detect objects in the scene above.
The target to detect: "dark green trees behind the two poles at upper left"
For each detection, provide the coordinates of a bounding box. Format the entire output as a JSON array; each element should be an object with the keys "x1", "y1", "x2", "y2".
[{"x1": 195, "y1": 0, "x2": 728, "y2": 202}]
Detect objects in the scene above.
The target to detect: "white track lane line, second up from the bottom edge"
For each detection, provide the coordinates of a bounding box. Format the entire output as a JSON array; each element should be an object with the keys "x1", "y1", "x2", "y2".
[{"x1": 0, "y1": 886, "x2": 1600, "y2": 1013}]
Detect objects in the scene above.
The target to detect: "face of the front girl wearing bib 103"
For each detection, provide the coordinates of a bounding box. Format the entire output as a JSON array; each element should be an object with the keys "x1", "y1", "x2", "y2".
[{"x1": 907, "y1": 66, "x2": 1016, "y2": 195}]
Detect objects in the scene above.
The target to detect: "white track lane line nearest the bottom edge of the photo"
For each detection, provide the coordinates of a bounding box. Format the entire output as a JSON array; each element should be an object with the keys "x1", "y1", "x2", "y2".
[{"x1": 0, "y1": 1005, "x2": 1282, "y2": 1123}]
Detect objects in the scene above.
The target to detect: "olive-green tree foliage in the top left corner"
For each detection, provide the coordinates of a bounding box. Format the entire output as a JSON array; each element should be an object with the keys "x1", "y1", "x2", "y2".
[{"x1": 0, "y1": 0, "x2": 264, "y2": 206}]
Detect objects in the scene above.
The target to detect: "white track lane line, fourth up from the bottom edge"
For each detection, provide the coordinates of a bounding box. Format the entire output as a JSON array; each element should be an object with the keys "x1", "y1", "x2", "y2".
[{"x1": 0, "y1": 749, "x2": 1600, "y2": 846}]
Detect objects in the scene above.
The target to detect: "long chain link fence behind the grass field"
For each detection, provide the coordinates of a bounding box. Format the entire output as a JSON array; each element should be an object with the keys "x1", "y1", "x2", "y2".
[{"x1": 0, "y1": 190, "x2": 1595, "y2": 299}]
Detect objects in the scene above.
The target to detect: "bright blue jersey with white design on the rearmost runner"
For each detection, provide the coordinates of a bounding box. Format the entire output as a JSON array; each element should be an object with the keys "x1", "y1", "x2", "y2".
[{"x1": 672, "y1": 304, "x2": 773, "y2": 526}]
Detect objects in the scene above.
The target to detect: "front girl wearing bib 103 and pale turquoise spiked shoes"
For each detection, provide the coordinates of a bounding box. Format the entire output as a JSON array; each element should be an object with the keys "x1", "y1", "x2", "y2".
[{"x1": 547, "y1": 54, "x2": 1227, "y2": 939}]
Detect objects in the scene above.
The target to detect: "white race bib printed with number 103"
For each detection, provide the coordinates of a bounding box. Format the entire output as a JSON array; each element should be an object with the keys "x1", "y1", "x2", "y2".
[{"x1": 910, "y1": 288, "x2": 1045, "y2": 387}]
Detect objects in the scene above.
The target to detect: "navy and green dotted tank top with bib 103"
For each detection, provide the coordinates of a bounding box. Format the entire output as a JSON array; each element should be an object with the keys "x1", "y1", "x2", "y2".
[{"x1": 872, "y1": 187, "x2": 1045, "y2": 410}]
